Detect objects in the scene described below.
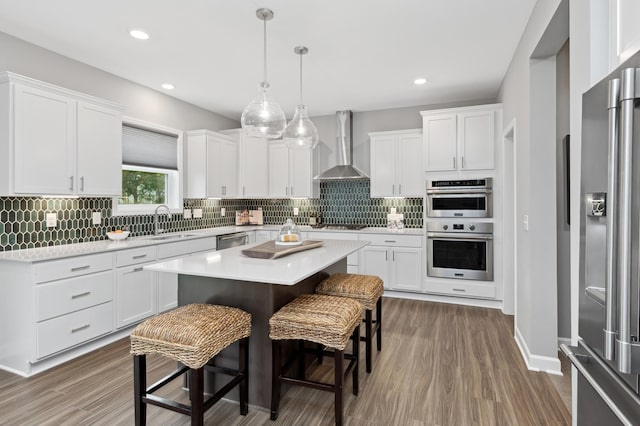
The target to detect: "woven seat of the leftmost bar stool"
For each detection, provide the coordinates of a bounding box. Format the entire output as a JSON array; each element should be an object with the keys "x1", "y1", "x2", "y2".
[{"x1": 131, "y1": 304, "x2": 251, "y2": 369}]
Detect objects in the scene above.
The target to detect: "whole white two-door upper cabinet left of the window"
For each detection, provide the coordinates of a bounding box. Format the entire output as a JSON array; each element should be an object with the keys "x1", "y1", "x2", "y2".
[{"x1": 0, "y1": 72, "x2": 122, "y2": 196}]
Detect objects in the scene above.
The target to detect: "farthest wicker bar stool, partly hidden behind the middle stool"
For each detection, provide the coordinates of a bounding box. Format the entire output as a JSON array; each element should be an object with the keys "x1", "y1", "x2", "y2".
[{"x1": 316, "y1": 273, "x2": 384, "y2": 373}]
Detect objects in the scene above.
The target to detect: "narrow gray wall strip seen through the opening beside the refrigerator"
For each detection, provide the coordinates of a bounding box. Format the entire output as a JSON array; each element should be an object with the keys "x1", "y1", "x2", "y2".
[{"x1": 556, "y1": 41, "x2": 577, "y2": 339}]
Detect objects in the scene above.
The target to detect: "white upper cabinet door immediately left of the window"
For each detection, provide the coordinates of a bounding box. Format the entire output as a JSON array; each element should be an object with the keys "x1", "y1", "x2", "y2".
[{"x1": 76, "y1": 102, "x2": 122, "y2": 197}]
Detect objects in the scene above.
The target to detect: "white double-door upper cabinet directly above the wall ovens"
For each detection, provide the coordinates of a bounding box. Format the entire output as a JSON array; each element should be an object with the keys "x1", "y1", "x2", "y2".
[{"x1": 420, "y1": 104, "x2": 502, "y2": 172}]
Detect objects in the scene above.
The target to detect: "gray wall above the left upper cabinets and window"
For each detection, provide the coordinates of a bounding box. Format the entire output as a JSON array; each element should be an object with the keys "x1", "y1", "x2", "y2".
[{"x1": 0, "y1": 32, "x2": 240, "y2": 130}]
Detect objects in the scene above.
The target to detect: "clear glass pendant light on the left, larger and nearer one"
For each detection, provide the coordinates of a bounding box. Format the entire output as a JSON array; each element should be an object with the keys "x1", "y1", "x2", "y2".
[{"x1": 240, "y1": 9, "x2": 287, "y2": 139}]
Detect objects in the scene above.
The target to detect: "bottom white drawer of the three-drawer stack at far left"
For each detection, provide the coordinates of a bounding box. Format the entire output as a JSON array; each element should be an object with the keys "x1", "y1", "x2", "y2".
[{"x1": 36, "y1": 302, "x2": 113, "y2": 358}]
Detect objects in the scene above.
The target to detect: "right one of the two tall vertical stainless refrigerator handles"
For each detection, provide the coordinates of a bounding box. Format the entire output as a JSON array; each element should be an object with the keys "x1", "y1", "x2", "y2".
[{"x1": 616, "y1": 68, "x2": 636, "y2": 374}]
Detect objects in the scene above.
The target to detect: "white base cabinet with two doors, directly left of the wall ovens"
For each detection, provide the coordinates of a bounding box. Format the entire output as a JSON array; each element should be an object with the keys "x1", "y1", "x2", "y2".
[{"x1": 360, "y1": 234, "x2": 423, "y2": 291}]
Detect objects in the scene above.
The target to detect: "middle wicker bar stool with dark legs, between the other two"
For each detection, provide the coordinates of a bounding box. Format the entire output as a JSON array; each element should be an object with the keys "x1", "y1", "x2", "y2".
[{"x1": 269, "y1": 294, "x2": 362, "y2": 425}]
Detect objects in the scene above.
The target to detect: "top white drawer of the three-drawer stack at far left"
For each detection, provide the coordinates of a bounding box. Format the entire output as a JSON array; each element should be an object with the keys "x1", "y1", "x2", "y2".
[{"x1": 36, "y1": 253, "x2": 113, "y2": 283}]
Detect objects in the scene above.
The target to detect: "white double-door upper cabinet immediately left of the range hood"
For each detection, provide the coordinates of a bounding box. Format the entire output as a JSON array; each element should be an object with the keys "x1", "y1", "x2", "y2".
[{"x1": 269, "y1": 142, "x2": 317, "y2": 198}]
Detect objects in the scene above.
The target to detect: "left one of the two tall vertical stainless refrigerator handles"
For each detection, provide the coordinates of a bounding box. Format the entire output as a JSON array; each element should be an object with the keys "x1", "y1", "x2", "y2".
[{"x1": 603, "y1": 78, "x2": 620, "y2": 361}]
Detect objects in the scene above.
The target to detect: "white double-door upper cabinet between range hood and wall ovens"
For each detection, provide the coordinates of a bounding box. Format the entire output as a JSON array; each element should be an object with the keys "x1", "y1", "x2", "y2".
[{"x1": 369, "y1": 129, "x2": 424, "y2": 198}]
